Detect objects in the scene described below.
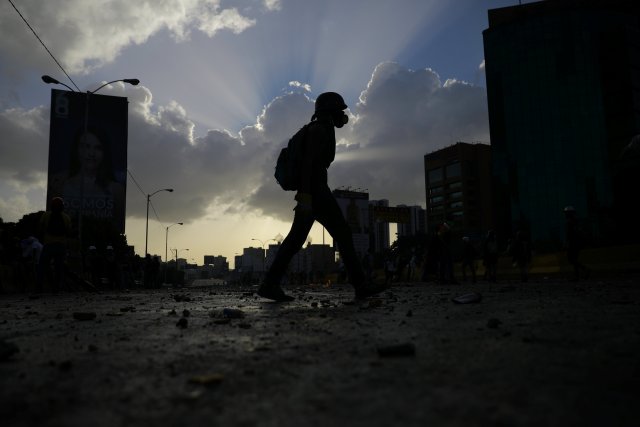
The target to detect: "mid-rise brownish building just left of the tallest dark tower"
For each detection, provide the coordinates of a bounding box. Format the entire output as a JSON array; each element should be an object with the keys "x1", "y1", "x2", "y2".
[{"x1": 424, "y1": 142, "x2": 494, "y2": 236}]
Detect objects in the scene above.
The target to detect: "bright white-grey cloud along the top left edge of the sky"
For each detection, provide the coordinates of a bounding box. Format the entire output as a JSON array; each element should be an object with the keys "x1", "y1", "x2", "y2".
[{"x1": 0, "y1": 0, "x2": 270, "y2": 76}]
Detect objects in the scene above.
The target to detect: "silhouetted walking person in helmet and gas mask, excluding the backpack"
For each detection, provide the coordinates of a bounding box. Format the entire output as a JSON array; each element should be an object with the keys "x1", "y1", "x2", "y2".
[{"x1": 258, "y1": 92, "x2": 384, "y2": 302}]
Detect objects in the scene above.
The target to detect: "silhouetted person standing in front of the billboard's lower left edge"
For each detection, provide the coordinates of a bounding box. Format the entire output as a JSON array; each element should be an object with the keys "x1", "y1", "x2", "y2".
[{"x1": 36, "y1": 197, "x2": 71, "y2": 292}]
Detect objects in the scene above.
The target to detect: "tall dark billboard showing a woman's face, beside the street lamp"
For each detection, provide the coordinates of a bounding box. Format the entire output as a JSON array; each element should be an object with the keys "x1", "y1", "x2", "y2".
[{"x1": 47, "y1": 89, "x2": 127, "y2": 233}]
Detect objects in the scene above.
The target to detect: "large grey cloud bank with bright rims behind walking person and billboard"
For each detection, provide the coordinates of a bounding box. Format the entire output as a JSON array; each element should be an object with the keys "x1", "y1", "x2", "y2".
[{"x1": 0, "y1": 63, "x2": 488, "y2": 227}]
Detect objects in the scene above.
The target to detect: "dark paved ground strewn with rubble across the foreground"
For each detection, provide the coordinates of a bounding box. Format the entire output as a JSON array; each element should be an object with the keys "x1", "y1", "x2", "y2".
[{"x1": 0, "y1": 277, "x2": 640, "y2": 427}]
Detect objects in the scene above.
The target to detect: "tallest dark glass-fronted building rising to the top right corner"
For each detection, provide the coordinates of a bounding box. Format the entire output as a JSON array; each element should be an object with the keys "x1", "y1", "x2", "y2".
[{"x1": 483, "y1": 0, "x2": 640, "y2": 249}]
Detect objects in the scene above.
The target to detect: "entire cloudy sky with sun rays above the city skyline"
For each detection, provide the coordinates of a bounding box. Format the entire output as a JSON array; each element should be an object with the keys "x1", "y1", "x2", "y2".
[{"x1": 0, "y1": 0, "x2": 518, "y2": 264}]
